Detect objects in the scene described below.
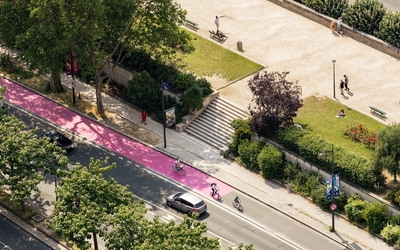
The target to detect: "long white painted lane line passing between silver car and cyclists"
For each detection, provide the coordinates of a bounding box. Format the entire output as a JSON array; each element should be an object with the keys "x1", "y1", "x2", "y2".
[{"x1": 139, "y1": 168, "x2": 304, "y2": 250}]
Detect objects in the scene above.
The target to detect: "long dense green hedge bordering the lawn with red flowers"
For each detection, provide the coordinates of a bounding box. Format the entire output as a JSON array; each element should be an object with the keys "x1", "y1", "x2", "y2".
[{"x1": 278, "y1": 126, "x2": 385, "y2": 188}]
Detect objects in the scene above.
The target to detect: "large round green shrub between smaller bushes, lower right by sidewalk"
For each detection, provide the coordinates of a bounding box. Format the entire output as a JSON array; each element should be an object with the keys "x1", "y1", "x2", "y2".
[{"x1": 364, "y1": 201, "x2": 387, "y2": 234}]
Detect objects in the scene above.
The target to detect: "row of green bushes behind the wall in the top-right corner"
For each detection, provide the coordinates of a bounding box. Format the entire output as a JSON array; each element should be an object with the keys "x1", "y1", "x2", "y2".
[{"x1": 295, "y1": 0, "x2": 400, "y2": 48}]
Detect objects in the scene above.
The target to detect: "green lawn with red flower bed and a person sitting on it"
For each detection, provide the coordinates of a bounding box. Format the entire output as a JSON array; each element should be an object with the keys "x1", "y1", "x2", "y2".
[{"x1": 293, "y1": 96, "x2": 386, "y2": 159}]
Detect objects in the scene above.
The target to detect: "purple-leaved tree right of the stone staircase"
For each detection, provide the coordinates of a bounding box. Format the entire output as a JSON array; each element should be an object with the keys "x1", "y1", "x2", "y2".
[{"x1": 249, "y1": 71, "x2": 303, "y2": 135}]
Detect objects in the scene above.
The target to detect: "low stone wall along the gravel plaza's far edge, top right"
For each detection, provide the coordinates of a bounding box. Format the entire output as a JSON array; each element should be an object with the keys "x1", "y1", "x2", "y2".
[{"x1": 269, "y1": 0, "x2": 400, "y2": 58}]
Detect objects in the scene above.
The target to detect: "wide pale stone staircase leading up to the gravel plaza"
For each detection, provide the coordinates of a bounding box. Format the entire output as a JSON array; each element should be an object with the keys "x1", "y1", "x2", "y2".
[{"x1": 185, "y1": 96, "x2": 248, "y2": 149}]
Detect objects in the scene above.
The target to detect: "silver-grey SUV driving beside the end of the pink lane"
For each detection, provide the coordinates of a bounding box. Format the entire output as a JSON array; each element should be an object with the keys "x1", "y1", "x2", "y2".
[{"x1": 167, "y1": 192, "x2": 207, "y2": 216}]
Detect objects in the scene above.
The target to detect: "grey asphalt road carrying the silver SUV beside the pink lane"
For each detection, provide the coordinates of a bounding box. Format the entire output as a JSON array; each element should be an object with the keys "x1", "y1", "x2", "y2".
[{"x1": 7, "y1": 102, "x2": 345, "y2": 250}]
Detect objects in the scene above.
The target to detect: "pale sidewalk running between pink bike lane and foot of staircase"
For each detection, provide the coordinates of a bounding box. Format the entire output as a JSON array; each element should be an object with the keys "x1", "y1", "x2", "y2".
[{"x1": 62, "y1": 76, "x2": 392, "y2": 250}]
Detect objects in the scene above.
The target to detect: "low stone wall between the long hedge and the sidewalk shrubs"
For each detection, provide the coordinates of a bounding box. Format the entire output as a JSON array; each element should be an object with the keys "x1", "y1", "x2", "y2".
[{"x1": 251, "y1": 136, "x2": 400, "y2": 217}]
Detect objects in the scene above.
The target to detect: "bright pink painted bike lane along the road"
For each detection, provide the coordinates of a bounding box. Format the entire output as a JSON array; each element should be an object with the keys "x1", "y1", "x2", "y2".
[{"x1": 0, "y1": 78, "x2": 235, "y2": 196}]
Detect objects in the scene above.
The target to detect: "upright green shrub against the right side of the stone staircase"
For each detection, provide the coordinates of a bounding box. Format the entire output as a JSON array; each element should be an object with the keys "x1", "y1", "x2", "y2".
[{"x1": 229, "y1": 119, "x2": 254, "y2": 156}]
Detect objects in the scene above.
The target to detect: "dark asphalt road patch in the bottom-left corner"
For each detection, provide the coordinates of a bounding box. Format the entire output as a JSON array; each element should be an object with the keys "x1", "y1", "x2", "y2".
[{"x1": 0, "y1": 215, "x2": 52, "y2": 250}]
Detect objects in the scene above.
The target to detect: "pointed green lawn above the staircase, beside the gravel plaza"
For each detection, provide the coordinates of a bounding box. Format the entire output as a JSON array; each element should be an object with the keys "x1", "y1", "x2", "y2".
[{"x1": 177, "y1": 28, "x2": 263, "y2": 81}]
